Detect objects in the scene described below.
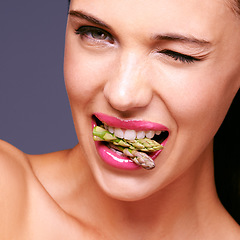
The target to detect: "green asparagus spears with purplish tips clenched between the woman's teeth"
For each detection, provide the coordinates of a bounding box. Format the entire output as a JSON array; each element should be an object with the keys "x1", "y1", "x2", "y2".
[{"x1": 93, "y1": 126, "x2": 163, "y2": 169}]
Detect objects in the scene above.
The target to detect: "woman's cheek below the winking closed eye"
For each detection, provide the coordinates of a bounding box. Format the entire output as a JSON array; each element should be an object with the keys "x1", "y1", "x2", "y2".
[{"x1": 158, "y1": 65, "x2": 235, "y2": 138}]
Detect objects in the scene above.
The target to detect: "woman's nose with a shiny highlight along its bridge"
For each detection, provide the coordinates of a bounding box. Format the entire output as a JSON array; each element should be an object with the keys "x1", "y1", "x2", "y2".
[{"x1": 103, "y1": 53, "x2": 152, "y2": 111}]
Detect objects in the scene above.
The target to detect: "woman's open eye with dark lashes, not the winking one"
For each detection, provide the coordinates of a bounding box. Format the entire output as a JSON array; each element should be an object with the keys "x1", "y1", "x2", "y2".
[{"x1": 75, "y1": 26, "x2": 114, "y2": 44}]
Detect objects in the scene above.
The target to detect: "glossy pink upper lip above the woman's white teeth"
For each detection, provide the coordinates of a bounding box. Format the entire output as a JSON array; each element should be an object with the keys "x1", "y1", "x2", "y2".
[{"x1": 94, "y1": 113, "x2": 169, "y2": 132}]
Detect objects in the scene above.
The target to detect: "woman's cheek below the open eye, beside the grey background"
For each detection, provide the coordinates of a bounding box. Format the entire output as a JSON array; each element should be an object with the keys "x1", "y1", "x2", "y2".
[{"x1": 64, "y1": 43, "x2": 112, "y2": 104}]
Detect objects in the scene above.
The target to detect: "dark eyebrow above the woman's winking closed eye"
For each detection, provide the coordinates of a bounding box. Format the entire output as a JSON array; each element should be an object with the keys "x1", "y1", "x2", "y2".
[{"x1": 153, "y1": 33, "x2": 211, "y2": 47}]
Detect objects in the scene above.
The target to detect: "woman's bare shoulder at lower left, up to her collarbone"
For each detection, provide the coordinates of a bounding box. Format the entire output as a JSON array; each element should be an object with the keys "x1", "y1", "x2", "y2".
[{"x1": 0, "y1": 140, "x2": 85, "y2": 240}]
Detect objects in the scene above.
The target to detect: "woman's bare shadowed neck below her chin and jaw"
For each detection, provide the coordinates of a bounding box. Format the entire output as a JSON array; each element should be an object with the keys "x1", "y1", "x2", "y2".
[{"x1": 69, "y1": 142, "x2": 223, "y2": 239}]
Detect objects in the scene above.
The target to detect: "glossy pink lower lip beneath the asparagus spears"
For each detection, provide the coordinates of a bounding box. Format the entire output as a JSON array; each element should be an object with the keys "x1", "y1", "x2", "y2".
[{"x1": 92, "y1": 122, "x2": 166, "y2": 170}]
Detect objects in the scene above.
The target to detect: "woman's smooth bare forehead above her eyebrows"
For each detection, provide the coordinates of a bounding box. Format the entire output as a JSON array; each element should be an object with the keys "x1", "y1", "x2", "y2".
[{"x1": 71, "y1": 0, "x2": 236, "y2": 37}]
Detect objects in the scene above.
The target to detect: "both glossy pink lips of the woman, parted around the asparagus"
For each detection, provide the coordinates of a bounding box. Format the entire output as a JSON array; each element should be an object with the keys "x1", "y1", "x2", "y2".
[{"x1": 92, "y1": 113, "x2": 168, "y2": 170}]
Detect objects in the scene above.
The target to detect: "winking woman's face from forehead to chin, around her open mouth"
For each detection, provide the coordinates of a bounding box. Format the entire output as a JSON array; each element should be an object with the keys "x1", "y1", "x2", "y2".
[{"x1": 64, "y1": 0, "x2": 240, "y2": 200}]
